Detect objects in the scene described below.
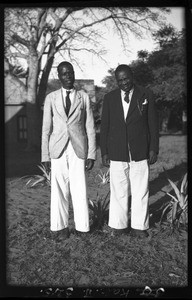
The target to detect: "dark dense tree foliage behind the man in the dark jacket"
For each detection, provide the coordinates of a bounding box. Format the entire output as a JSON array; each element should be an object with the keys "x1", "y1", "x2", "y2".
[{"x1": 99, "y1": 25, "x2": 187, "y2": 132}]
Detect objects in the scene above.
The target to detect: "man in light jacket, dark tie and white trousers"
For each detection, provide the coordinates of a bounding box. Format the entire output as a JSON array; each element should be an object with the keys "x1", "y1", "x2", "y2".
[{"x1": 41, "y1": 61, "x2": 96, "y2": 239}]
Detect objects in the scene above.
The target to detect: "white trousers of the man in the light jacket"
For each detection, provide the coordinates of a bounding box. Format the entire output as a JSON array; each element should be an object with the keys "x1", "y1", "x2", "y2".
[{"x1": 50, "y1": 142, "x2": 90, "y2": 232}]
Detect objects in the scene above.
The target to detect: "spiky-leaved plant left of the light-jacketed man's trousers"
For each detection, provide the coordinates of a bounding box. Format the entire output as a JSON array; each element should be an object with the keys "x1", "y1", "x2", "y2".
[{"x1": 20, "y1": 164, "x2": 51, "y2": 187}]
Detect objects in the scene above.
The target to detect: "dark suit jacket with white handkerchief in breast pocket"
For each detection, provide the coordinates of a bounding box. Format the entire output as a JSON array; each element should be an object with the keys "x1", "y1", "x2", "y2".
[{"x1": 100, "y1": 85, "x2": 159, "y2": 161}]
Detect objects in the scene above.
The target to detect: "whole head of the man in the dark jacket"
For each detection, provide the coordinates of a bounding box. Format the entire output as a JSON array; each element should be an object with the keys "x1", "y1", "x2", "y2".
[{"x1": 115, "y1": 65, "x2": 133, "y2": 92}]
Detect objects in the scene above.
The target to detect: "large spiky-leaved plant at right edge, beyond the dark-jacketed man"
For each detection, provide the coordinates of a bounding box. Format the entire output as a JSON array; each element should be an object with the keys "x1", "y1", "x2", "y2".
[{"x1": 160, "y1": 173, "x2": 188, "y2": 227}]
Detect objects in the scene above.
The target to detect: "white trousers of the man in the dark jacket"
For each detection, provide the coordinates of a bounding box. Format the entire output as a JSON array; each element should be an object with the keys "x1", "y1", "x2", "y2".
[{"x1": 108, "y1": 160, "x2": 149, "y2": 230}]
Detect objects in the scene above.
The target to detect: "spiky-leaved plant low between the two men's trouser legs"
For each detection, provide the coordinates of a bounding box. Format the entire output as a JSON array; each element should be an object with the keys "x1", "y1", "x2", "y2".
[{"x1": 89, "y1": 191, "x2": 110, "y2": 229}]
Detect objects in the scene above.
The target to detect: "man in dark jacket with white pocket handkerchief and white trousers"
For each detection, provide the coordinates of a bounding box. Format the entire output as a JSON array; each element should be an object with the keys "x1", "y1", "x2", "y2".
[{"x1": 100, "y1": 65, "x2": 159, "y2": 237}]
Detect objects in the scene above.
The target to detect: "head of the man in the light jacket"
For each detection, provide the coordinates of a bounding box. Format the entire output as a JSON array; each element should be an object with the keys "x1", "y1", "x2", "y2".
[{"x1": 57, "y1": 61, "x2": 75, "y2": 90}]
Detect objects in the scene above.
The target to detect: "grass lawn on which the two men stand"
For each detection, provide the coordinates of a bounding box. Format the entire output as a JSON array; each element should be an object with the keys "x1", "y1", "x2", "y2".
[{"x1": 3, "y1": 135, "x2": 188, "y2": 298}]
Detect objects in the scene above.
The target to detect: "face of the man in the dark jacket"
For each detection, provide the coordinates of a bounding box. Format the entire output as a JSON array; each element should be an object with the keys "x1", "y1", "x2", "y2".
[{"x1": 116, "y1": 70, "x2": 133, "y2": 92}]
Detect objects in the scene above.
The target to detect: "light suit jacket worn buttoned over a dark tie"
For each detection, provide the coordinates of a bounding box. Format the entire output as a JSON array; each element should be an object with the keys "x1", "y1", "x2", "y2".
[{"x1": 41, "y1": 89, "x2": 96, "y2": 162}]
